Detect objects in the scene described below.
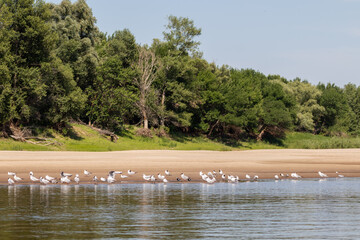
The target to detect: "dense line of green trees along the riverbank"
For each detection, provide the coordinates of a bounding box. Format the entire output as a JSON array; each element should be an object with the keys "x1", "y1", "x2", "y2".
[{"x1": 0, "y1": 0, "x2": 360, "y2": 140}]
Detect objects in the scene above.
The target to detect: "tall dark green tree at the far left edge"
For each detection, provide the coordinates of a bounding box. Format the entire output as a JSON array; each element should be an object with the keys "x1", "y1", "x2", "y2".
[{"x1": 0, "y1": 0, "x2": 56, "y2": 130}]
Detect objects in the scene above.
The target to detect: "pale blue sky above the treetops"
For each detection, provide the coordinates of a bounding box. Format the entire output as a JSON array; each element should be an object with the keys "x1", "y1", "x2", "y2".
[{"x1": 47, "y1": 0, "x2": 360, "y2": 87}]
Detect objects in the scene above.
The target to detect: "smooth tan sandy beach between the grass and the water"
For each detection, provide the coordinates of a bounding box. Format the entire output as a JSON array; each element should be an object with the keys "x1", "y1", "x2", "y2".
[{"x1": 0, "y1": 149, "x2": 360, "y2": 184}]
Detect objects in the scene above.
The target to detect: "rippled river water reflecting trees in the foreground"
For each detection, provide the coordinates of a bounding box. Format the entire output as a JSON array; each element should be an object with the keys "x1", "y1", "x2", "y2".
[{"x1": 0, "y1": 178, "x2": 360, "y2": 239}]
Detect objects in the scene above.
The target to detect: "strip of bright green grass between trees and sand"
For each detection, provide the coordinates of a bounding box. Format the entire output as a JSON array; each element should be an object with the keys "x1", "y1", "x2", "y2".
[{"x1": 0, "y1": 124, "x2": 360, "y2": 151}]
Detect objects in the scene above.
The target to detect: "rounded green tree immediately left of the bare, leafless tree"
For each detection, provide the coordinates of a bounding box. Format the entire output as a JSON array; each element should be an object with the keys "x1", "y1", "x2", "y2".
[{"x1": 87, "y1": 29, "x2": 137, "y2": 131}]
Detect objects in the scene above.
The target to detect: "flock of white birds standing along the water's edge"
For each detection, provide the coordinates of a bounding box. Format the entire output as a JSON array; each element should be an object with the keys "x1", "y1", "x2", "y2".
[{"x1": 8, "y1": 170, "x2": 344, "y2": 185}]
